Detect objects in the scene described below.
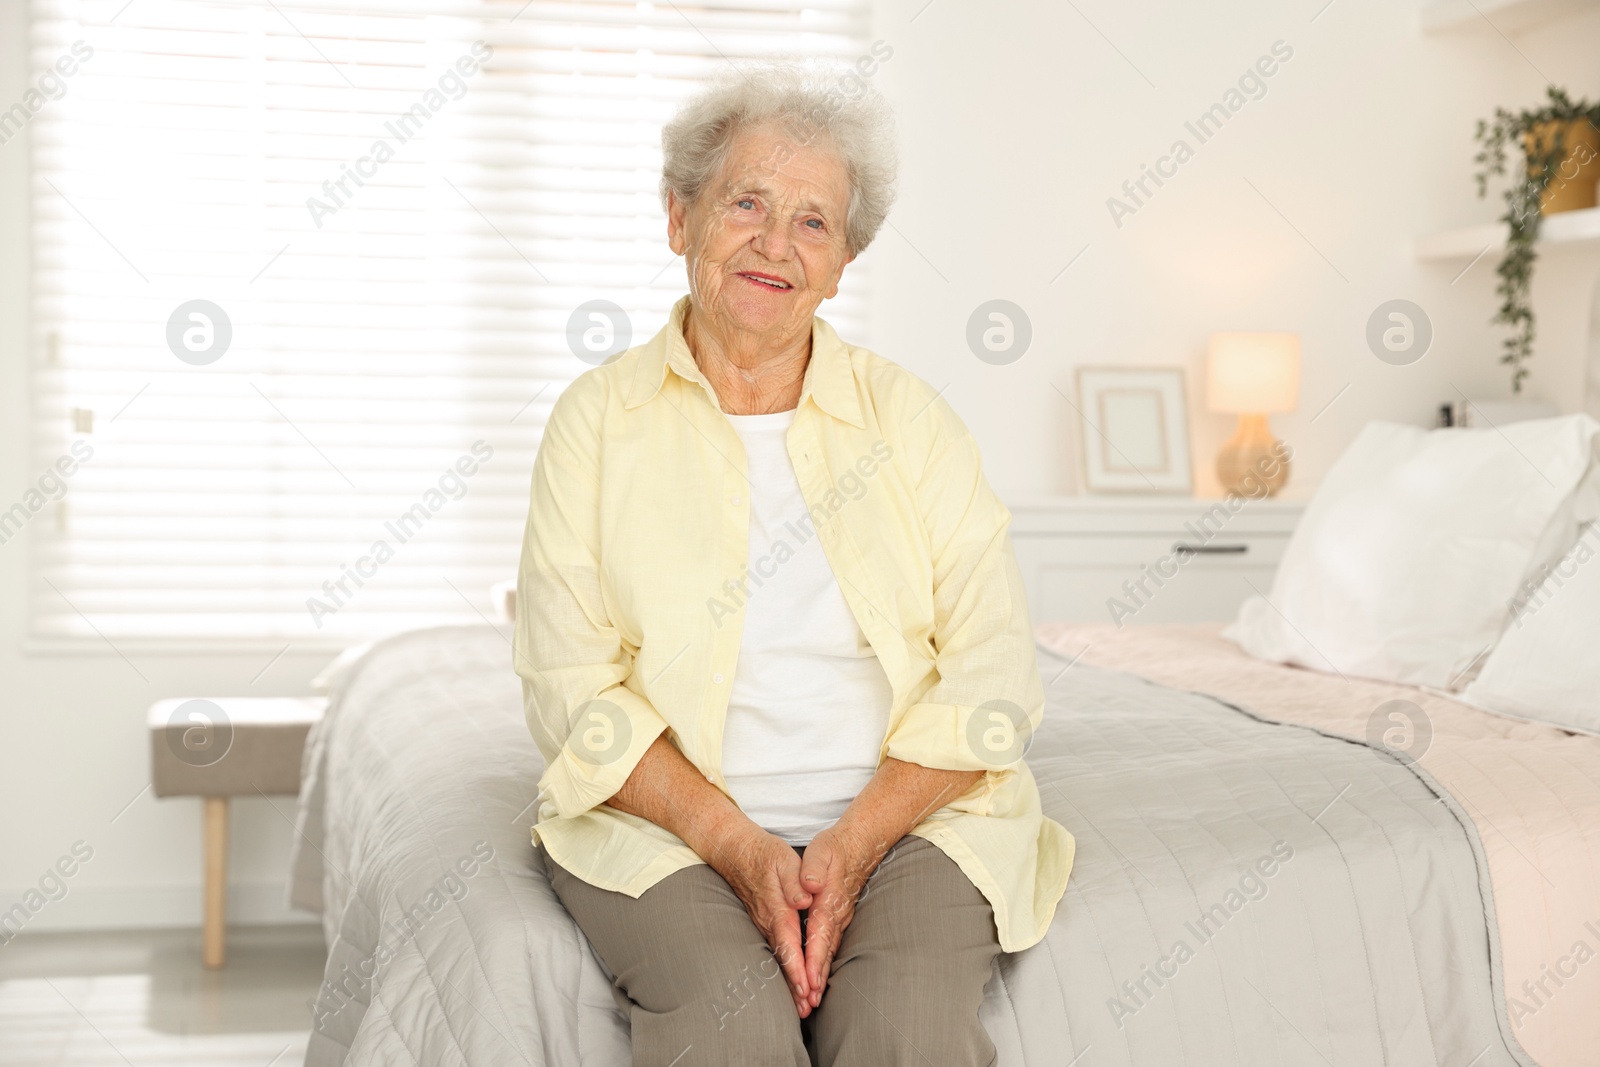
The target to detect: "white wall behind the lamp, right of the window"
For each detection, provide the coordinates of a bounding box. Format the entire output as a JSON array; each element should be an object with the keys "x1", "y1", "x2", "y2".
[{"x1": 867, "y1": 0, "x2": 1600, "y2": 499}]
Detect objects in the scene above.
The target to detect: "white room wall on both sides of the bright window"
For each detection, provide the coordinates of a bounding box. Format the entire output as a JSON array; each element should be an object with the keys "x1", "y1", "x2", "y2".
[{"x1": 0, "y1": 0, "x2": 1600, "y2": 927}]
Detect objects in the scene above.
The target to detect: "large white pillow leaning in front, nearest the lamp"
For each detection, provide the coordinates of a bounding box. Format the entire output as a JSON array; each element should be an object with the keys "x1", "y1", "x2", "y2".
[{"x1": 1224, "y1": 414, "x2": 1600, "y2": 689}]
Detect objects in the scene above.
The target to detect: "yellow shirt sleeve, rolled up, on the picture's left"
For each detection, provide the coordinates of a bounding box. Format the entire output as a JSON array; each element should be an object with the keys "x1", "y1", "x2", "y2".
[{"x1": 512, "y1": 397, "x2": 667, "y2": 817}]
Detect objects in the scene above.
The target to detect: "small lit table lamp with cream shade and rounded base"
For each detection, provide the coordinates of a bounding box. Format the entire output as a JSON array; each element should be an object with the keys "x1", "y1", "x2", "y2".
[{"x1": 1206, "y1": 333, "x2": 1299, "y2": 496}]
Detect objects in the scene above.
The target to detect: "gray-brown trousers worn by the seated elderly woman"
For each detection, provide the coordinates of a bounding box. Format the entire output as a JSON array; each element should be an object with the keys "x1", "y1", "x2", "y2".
[{"x1": 539, "y1": 837, "x2": 1000, "y2": 1067}]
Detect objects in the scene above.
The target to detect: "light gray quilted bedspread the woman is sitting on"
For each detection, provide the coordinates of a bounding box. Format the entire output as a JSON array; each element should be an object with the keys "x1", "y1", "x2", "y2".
[{"x1": 291, "y1": 625, "x2": 1533, "y2": 1067}]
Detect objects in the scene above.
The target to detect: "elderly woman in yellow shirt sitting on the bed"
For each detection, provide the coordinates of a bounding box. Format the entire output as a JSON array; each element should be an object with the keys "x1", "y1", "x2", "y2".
[{"x1": 515, "y1": 66, "x2": 1072, "y2": 1067}]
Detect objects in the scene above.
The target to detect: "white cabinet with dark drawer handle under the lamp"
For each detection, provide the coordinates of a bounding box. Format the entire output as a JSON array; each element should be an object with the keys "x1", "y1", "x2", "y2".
[{"x1": 1008, "y1": 496, "x2": 1306, "y2": 624}]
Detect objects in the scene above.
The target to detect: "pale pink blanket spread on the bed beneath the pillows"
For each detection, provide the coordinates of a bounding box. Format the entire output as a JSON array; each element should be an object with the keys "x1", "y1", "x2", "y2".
[{"x1": 1035, "y1": 622, "x2": 1600, "y2": 1067}]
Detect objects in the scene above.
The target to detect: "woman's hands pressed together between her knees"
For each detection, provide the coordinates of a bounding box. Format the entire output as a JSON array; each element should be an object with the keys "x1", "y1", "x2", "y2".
[{"x1": 706, "y1": 819, "x2": 893, "y2": 1019}]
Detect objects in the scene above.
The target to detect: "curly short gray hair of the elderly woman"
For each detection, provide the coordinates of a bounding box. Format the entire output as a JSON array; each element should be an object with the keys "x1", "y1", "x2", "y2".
[{"x1": 661, "y1": 62, "x2": 898, "y2": 256}]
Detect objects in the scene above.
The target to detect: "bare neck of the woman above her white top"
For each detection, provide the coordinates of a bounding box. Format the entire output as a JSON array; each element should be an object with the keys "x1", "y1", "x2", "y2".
[{"x1": 683, "y1": 306, "x2": 811, "y2": 414}]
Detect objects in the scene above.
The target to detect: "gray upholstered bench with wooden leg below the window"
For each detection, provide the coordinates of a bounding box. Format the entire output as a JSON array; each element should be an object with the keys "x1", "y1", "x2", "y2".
[{"x1": 149, "y1": 697, "x2": 326, "y2": 968}]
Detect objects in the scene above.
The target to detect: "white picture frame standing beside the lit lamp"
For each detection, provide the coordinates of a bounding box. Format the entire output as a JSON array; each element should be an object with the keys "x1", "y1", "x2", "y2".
[{"x1": 1077, "y1": 366, "x2": 1194, "y2": 494}]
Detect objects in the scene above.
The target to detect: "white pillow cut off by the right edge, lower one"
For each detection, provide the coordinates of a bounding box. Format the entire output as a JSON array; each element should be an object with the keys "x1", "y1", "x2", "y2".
[{"x1": 1461, "y1": 525, "x2": 1600, "y2": 734}]
